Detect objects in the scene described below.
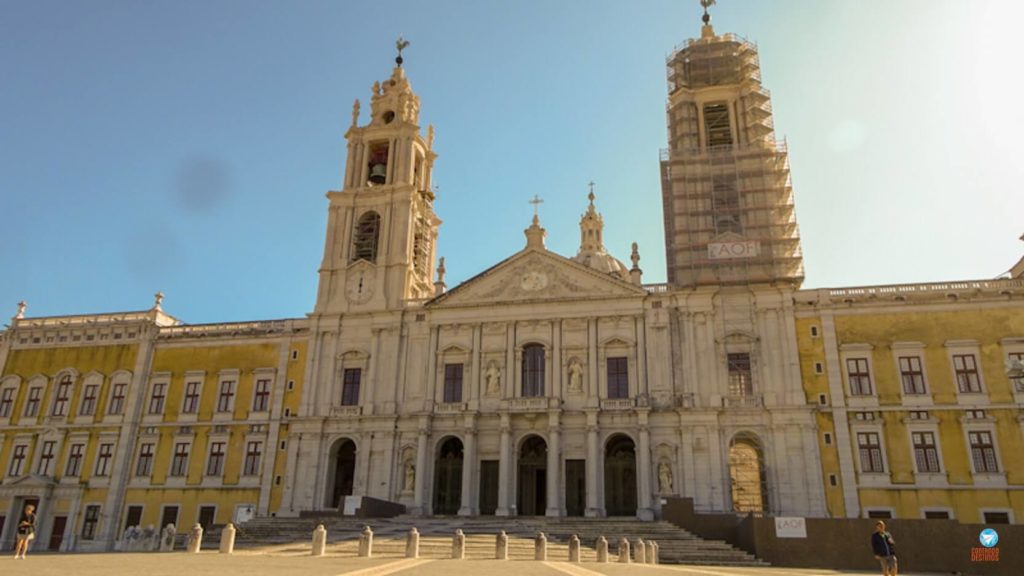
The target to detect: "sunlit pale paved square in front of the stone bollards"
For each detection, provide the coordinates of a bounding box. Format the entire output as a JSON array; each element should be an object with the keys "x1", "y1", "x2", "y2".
[{"x1": 0, "y1": 551, "x2": 946, "y2": 576}]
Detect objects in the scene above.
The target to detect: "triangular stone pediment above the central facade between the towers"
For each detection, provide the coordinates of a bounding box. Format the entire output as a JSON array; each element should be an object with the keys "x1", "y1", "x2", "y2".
[{"x1": 427, "y1": 248, "x2": 646, "y2": 307}]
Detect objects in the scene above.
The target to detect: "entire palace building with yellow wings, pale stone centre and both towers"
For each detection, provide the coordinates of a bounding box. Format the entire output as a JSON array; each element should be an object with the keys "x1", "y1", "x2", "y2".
[{"x1": 0, "y1": 15, "x2": 1024, "y2": 549}]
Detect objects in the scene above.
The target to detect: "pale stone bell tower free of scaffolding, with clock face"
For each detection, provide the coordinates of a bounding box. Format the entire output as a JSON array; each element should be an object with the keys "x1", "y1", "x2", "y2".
[{"x1": 315, "y1": 38, "x2": 441, "y2": 314}]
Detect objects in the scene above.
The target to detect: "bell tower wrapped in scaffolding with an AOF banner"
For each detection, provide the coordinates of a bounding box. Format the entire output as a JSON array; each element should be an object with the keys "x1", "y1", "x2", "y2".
[{"x1": 662, "y1": 25, "x2": 804, "y2": 286}]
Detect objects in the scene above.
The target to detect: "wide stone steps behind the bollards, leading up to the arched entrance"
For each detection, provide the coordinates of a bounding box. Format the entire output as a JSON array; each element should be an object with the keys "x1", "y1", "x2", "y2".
[{"x1": 209, "y1": 516, "x2": 767, "y2": 566}]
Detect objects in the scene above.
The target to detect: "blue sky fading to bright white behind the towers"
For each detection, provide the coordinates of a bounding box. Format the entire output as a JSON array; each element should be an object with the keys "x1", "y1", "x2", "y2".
[{"x1": 0, "y1": 0, "x2": 1024, "y2": 323}]
